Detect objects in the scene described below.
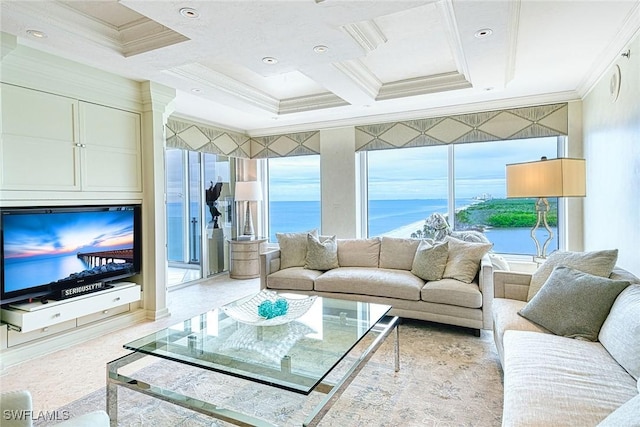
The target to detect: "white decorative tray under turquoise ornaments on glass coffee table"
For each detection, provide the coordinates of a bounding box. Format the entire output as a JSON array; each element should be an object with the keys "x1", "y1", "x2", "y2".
[{"x1": 222, "y1": 290, "x2": 316, "y2": 326}]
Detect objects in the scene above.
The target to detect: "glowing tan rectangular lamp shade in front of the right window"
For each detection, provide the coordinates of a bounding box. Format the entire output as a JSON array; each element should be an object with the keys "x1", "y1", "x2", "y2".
[{"x1": 507, "y1": 158, "x2": 586, "y2": 198}]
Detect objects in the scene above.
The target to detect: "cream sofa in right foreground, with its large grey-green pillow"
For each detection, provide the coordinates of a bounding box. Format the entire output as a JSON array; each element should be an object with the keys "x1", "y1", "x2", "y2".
[{"x1": 493, "y1": 251, "x2": 640, "y2": 427}]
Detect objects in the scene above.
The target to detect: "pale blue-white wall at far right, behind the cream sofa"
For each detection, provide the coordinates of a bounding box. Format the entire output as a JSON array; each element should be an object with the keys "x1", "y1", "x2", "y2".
[{"x1": 583, "y1": 31, "x2": 640, "y2": 275}]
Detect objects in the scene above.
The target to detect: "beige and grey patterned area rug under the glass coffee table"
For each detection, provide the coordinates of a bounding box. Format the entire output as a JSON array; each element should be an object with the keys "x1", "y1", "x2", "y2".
[{"x1": 37, "y1": 320, "x2": 503, "y2": 427}]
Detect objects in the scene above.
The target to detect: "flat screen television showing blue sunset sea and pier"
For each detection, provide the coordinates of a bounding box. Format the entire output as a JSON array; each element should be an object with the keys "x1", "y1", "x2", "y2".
[{"x1": 0, "y1": 205, "x2": 142, "y2": 305}]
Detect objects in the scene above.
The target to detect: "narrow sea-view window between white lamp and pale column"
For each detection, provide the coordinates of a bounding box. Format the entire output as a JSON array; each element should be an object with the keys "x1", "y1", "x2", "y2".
[{"x1": 268, "y1": 155, "x2": 321, "y2": 242}]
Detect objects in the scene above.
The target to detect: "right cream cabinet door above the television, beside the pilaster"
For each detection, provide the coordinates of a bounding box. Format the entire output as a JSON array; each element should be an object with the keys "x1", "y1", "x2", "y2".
[{"x1": 79, "y1": 102, "x2": 142, "y2": 191}]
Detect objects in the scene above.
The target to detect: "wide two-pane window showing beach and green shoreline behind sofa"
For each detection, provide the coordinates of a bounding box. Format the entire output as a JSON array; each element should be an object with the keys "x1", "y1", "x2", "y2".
[{"x1": 367, "y1": 137, "x2": 558, "y2": 254}]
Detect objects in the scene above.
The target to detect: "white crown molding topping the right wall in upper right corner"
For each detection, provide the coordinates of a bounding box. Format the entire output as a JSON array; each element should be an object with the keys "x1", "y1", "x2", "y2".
[{"x1": 577, "y1": 2, "x2": 640, "y2": 99}]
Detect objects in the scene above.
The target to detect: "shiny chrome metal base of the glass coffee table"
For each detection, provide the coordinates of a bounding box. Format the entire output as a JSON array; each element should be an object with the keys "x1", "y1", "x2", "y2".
[{"x1": 107, "y1": 317, "x2": 400, "y2": 427}]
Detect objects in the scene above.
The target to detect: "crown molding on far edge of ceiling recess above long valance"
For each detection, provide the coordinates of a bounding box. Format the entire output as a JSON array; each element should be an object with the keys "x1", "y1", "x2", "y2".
[{"x1": 376, "y1": 72, "x2": 471, "y2": 101}]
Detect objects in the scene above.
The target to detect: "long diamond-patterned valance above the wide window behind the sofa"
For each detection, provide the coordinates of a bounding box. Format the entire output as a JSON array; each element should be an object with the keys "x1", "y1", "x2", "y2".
[{"x1": 356, "y1": 103, "x2": 568, "y2": 151}]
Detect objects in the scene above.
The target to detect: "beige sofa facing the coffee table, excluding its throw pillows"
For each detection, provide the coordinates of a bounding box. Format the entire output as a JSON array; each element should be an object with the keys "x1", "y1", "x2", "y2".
[{"x1": 260, "y1": 237, "x2": 493, "y2": 335}]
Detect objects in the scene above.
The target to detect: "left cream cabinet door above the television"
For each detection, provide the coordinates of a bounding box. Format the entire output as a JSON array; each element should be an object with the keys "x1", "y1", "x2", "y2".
[{"x1": 0, "y1": 84, "x2": 80, "y2": 190}]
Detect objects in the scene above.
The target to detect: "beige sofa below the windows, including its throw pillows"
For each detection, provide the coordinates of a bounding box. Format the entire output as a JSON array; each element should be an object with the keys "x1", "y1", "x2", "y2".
[{"x1": 260, "y1": 233, "x2": 493, "y2": 335}]
